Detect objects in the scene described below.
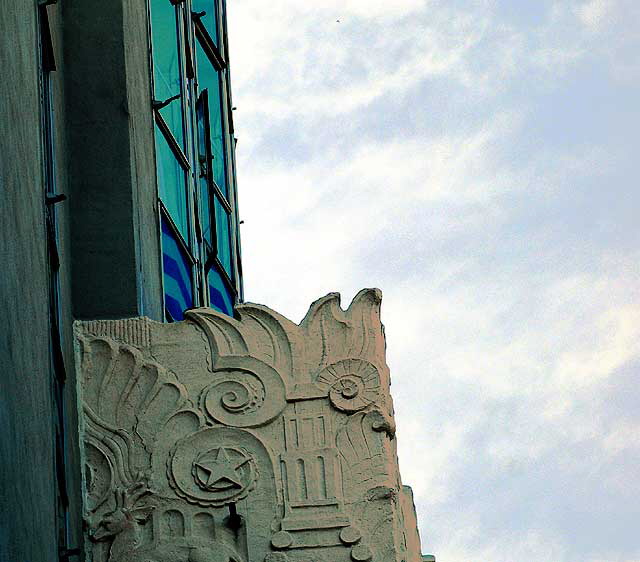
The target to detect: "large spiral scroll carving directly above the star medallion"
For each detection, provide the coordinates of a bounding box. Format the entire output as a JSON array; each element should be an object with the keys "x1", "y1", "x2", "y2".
[{"x1": 200, "y1": 356, "x2": 286, "y2": 427}]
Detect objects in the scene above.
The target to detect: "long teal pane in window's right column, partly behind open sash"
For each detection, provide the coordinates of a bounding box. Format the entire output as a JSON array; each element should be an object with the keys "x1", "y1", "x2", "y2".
[{"x1": 196, "y1": 41, "x2": 229, "y2": 199}]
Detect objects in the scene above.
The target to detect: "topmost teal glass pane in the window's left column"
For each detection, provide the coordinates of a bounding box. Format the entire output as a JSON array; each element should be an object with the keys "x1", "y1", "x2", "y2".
[{"x1": 151, "y1": 0, "x2": 184, "y2": 146}]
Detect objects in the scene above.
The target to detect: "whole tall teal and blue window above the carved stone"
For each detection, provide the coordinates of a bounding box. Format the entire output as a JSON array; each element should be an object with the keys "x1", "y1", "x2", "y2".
[{"x1": 150, "y1": 0, "x2": 242, "y2": 321}]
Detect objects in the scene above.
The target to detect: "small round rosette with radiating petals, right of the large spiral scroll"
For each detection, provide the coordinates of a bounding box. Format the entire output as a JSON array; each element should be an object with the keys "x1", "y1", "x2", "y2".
[{"x1": 316, "y1": 359, "x2": 380, "y2": 412}]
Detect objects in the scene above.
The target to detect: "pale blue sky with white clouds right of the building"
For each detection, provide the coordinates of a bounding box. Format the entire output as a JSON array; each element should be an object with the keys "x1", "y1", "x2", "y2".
[{"x1": 228, "y1": 0, "x2": 640, "y2": 562}]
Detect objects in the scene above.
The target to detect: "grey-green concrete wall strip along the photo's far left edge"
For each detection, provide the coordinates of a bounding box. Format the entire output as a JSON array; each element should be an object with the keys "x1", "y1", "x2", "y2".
[{"x1": 0, "y1": 2, "x2": 57, "y2": 562}]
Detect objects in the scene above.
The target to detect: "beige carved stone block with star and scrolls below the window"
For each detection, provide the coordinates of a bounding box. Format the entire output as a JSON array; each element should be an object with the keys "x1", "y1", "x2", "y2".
[{"x1": 76, "y1": 289, "x2": 422, "y2": 562}]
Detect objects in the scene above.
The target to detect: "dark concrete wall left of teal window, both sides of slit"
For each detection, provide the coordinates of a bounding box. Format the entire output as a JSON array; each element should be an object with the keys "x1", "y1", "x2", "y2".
[{"x1": 0, "y1": 0, "x2": 162, "y2": 562}]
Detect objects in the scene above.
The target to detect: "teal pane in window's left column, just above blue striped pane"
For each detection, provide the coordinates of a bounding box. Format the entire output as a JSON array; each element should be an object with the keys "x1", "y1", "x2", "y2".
[{"x1": 155, "y1": 127, "x2": 189, "y2": 241}]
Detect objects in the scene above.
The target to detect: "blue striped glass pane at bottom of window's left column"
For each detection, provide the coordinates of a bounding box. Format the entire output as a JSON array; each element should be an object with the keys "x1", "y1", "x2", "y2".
[{"x1": 162, "y1": 219, "x2": 193, "y2": 320}]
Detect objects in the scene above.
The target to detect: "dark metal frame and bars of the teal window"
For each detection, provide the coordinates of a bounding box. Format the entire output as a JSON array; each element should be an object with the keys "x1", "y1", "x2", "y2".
[{"x1": 147, "y1": 0, "x2": 243, "y2": 321}]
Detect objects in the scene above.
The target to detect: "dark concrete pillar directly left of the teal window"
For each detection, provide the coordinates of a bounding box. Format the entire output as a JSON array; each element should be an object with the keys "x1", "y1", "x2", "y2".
[{"x1": 63, "y1": 0, "x2": 162, "y2": 320}]
